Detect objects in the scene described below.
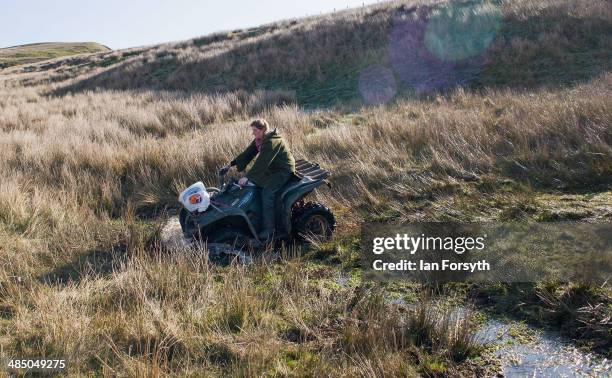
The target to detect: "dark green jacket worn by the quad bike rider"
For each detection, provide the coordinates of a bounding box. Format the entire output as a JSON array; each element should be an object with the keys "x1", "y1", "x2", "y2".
[{"x1": 233, "y1": 129, "x2": 295, "y2": 188}]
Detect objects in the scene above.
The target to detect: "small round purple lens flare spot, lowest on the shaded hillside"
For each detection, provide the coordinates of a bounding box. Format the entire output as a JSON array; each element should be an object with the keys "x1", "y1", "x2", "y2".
[{"x1": 358, "y1": 65, "x2": 397, "y2": 105}]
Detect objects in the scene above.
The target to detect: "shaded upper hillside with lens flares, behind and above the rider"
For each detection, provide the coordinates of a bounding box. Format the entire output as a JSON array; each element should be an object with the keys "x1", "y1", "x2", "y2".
[{"x1": 7, "y1": 0, "x2": 612, "y2": 106}]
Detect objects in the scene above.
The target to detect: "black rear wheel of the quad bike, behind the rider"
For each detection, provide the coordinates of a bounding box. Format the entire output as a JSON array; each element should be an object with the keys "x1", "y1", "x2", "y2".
[{"x1": 292, "y1": 202, "x2": 336, "y2": 241}]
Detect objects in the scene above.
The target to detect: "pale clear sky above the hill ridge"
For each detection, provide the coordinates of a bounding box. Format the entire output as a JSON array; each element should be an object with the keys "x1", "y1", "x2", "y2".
[{"x1": 0, "y1": 0, "x2": 378, "y2": 49}]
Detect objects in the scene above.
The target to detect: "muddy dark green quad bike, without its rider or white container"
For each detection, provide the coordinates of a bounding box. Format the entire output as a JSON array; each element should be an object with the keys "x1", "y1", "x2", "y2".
[{"x1": 179, "y1": 160, "x2": 336, "y2": 255}]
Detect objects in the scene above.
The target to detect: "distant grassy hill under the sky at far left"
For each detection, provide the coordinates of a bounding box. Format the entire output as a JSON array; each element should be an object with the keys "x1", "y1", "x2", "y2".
[{"x1": 0, "y1": 42, "x2": 110, "y2": 68}]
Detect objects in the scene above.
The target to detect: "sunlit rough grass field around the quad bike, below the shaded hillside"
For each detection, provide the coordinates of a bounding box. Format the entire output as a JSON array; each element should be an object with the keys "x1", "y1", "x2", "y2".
[{"x1": 0, "y1": 76, "x2": 612, "y2": 375}]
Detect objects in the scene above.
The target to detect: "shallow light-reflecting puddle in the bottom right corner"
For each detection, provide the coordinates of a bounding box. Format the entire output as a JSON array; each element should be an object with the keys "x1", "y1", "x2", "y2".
[{"x1": 477, "y1": 320, "x2": 612, "y2": 377}]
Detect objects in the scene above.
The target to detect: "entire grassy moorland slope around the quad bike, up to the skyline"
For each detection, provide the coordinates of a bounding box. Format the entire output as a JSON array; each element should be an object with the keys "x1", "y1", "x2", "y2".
[{"x1": 0, "y1": 0, "x2": 612, "y2": 376}]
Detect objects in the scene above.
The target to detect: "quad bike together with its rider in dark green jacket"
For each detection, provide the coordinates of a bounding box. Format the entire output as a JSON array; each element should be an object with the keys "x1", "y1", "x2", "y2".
[{"x1": 179, "y1": 120, "x2": 335, "y2": 248}]
